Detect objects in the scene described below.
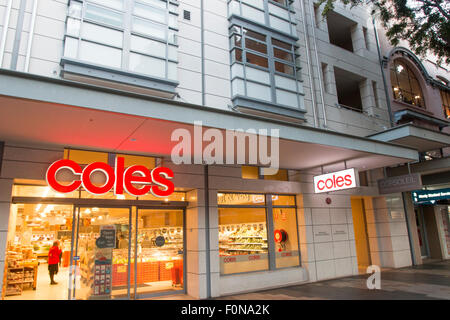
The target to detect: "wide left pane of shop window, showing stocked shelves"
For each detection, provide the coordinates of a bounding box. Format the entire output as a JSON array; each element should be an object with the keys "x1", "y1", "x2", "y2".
[{"x1": 219, "y1": 208, "x2": 269, "y2": 274}]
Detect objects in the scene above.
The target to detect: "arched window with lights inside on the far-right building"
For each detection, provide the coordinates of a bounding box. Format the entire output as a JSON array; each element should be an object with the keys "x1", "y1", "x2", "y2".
[{"x1": 391, "y1": 59, "x2": 425, "y2": 108}]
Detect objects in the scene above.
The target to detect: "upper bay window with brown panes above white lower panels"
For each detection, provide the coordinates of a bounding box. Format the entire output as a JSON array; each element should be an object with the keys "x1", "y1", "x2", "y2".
[{"x1": 230, "y1": 25, "x2": 303, "y2": 109}]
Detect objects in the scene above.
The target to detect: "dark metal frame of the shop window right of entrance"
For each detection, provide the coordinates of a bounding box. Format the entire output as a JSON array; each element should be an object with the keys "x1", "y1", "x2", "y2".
[{"x1": 217, "y1": 191, "x2": 302, "y2": 277}]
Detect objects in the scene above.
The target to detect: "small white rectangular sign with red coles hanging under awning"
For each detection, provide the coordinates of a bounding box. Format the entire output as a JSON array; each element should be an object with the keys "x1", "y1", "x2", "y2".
[{"x1": 314, "y1": 169, "x2": 359, "y2": 193}]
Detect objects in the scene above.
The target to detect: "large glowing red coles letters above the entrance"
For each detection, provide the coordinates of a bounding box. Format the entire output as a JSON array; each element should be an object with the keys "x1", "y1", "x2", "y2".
[{"x1": 46, "y1": 157, "x2": 175, "y2": 197}]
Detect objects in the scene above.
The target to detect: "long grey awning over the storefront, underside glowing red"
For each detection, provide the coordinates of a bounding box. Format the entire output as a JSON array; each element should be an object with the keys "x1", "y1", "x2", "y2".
[{"x1": 0, "y1": 70, "x2": 418, "y2": 170}]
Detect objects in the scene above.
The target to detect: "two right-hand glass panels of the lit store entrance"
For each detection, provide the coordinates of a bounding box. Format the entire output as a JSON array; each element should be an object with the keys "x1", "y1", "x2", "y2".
[{"x1": 69, "y1": 206, "x2": 185, "y2": 300}]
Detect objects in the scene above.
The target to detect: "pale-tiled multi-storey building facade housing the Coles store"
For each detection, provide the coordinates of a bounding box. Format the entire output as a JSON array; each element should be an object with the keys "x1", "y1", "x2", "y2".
[{"x1": 0, "y1": 0, "x2": 448, "y2": 299}]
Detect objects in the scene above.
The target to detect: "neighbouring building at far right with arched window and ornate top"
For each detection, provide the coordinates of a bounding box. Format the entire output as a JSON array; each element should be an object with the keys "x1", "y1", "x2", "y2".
[{"x1": 372, "y1": 32, "x2": 450, "y2": 264}]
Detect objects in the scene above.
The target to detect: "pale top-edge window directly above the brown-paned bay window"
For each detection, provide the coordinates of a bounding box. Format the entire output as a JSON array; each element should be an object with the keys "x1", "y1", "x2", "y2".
[{"x1": 228, "y1": 0, "x2": 297, "y2": 36}]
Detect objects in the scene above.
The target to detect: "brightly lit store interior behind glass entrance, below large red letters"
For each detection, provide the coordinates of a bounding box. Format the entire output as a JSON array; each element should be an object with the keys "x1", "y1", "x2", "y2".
[{"x1": 2, "y1": 203, "x2": 184, "y2": 300}]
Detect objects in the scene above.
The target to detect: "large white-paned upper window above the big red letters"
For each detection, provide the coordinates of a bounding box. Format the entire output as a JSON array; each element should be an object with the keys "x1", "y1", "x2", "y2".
[{"x1": 64, "y1": 0, "x2": 178, "y2": 80}]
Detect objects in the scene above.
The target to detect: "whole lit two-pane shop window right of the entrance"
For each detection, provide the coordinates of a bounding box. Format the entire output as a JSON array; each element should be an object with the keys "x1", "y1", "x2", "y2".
[{"x1": 217, "y1": 193, "x2": 300, "y2": 275}]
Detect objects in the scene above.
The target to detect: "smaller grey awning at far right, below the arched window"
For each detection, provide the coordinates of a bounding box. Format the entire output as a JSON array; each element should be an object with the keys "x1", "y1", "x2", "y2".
[{"x1": 369, "y1": 124, "x2": 450, "y2": 152}]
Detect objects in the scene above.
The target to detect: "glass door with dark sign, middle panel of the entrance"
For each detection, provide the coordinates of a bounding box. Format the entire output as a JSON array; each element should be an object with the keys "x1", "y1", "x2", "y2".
[{"x1": 69, "y1": 206, "x2": 132, "y2": 300}]
